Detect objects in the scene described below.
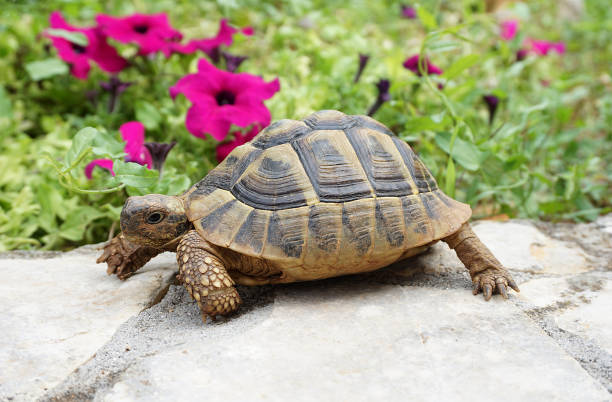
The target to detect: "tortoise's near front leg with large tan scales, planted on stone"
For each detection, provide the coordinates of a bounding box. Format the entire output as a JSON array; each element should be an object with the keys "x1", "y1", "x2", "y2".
[{"x1": 176, "y1": 230, "x2": 241, "y2": 322}]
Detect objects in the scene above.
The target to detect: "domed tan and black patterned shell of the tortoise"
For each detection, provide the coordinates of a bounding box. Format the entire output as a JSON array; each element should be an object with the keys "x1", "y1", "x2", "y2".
[{"x1": 184, "y1": 110, "x2": 471, "y2": 277}]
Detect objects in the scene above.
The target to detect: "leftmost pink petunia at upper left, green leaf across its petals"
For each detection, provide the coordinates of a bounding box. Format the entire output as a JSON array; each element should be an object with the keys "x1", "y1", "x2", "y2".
[{"x1": 45, "y1": 11, "x2": 127, "y2": 79}]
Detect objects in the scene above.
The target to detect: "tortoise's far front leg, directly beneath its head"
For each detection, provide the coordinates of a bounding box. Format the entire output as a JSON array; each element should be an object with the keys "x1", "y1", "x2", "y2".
[{"x1": 96, "y1": 233, "x2": 164, "y2": 280}]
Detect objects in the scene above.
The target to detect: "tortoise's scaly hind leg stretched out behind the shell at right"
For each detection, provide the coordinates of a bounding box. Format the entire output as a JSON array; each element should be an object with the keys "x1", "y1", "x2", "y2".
[{"x1": 443, "y1": 222, "x2": 520, "y2": 300}]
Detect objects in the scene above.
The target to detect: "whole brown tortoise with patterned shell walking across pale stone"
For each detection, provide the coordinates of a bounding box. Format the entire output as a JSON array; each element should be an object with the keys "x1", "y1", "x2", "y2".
[{"x1": 98, "y1": 110, "x2": 519, "y2": 320}]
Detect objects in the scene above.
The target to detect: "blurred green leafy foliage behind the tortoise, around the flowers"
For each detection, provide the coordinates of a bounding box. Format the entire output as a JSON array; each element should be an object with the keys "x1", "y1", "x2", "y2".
[{"x1": 0, "y1": 0, "x2": 612, "y2": 251}]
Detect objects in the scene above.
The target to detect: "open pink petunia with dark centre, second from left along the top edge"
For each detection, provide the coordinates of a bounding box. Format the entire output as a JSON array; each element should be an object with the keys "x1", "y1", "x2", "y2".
[{"x1": 96, "y1": 13, "x2": 183, "y2": 55}]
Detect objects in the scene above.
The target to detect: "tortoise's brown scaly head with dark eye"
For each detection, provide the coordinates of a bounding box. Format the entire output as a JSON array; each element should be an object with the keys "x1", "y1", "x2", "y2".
[{"x1": 121, "y1": 194, "x2": 191, "y2": 248}]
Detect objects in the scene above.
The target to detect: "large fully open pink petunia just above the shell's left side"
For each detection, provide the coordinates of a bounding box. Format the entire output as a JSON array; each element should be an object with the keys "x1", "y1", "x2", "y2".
[{"x1": 170, "y1": 59, "x2": 280, "y2": 141}]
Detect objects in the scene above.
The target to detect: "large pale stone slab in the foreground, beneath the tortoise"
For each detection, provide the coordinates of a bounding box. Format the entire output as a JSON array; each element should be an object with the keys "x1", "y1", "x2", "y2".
[{"x1": 99, "y1": 279, "x2": 609, "y2": 401}]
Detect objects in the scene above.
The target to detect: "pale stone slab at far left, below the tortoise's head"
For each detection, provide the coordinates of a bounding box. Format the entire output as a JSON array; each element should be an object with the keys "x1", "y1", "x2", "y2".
[{"x1": 0, "y1": 250, "x2": 176, "y2": 400}]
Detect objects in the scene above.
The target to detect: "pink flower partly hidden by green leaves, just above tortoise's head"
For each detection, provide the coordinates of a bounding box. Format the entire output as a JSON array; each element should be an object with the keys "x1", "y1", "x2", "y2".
[{"x1": 85, "y1": 121, "x2": 153, "y2": 179}]
